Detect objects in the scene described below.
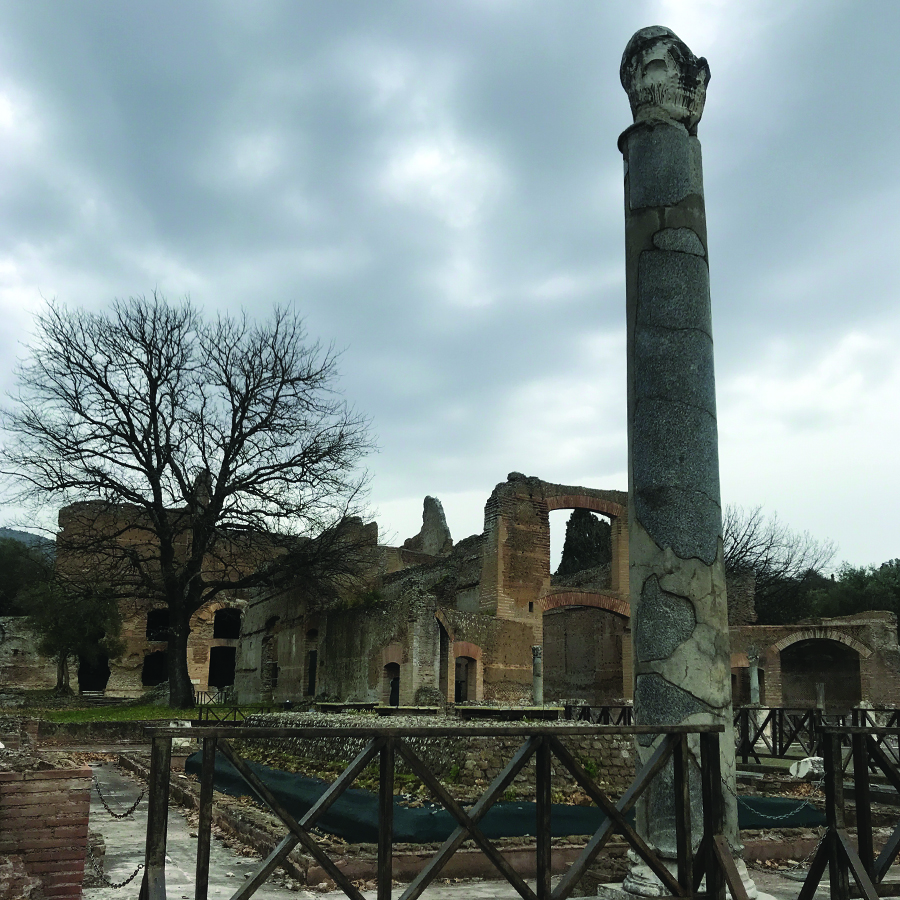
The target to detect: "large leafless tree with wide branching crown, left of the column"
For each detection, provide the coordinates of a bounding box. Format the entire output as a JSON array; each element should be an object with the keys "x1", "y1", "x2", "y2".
[{"x1": 0, "y1": 294, "x2": 372, "y2": 708}]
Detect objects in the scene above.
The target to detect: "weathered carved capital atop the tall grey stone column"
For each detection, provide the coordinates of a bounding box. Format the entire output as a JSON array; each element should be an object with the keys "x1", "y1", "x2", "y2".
[{"x1": 619, "y1": 25, "x2": 709, "y2": 134}]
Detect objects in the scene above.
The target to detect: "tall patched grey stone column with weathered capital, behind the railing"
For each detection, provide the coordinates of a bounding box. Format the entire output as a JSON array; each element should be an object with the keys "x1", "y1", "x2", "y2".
[{"x1": 619, "y1": 27, "x2": 756, "y2": 896}]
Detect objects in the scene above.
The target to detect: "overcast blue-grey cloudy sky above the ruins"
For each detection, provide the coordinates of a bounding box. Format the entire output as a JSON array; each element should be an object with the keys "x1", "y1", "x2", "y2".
[{"x1": 0, "y1": 0, "x2": 900, "y2": 564}]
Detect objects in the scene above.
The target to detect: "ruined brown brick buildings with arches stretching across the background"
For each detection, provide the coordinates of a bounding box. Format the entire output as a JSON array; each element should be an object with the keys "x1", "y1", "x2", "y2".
[{"x1": 0, "y1": 472, "x2": 900, "y2": 710}]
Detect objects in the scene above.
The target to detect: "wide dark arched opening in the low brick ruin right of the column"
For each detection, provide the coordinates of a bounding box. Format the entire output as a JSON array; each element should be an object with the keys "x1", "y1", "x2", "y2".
[{"x1": 781, "y1": 638, "x2": 862, "y2": 713}]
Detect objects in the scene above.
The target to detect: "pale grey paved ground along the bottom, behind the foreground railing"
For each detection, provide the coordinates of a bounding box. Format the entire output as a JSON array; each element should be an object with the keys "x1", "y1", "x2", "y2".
[{"x1": 84, "y1": 762, "x2": 829, "y2": 900}]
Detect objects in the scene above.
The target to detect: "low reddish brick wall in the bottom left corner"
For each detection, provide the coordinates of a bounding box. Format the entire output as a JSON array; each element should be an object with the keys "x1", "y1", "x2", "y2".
[{"x1": 0, "y1": 766, "x2": 91, "y2": 900}]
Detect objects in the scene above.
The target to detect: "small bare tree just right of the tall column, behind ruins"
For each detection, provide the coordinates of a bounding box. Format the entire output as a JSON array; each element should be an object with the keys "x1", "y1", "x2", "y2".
[{"x1": 722, "y1": 504, "x2": 837, "y2": 624}]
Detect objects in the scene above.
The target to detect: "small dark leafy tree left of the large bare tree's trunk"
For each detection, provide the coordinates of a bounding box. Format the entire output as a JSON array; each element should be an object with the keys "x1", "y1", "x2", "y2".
[{"x1": 22, "y1": 580, "x2": 124, "y2": 694}]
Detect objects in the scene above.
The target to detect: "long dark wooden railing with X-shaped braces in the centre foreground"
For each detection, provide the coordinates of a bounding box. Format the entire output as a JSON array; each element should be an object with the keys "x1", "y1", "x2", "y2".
[{"x1": 140, "y1": 725, "x2": 747, "y2": 900}]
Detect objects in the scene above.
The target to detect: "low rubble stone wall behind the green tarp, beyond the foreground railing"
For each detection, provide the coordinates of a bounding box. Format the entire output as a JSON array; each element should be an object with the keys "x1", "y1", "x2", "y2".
[{"x1": 247, "y1": 713, "x2": 635, "y2": 800}]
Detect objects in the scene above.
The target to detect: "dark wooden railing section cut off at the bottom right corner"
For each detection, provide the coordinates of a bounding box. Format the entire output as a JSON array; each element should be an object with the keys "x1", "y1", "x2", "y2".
[{"x1": 799, "y1": 724, "x2": 900, "y2": 900}]
